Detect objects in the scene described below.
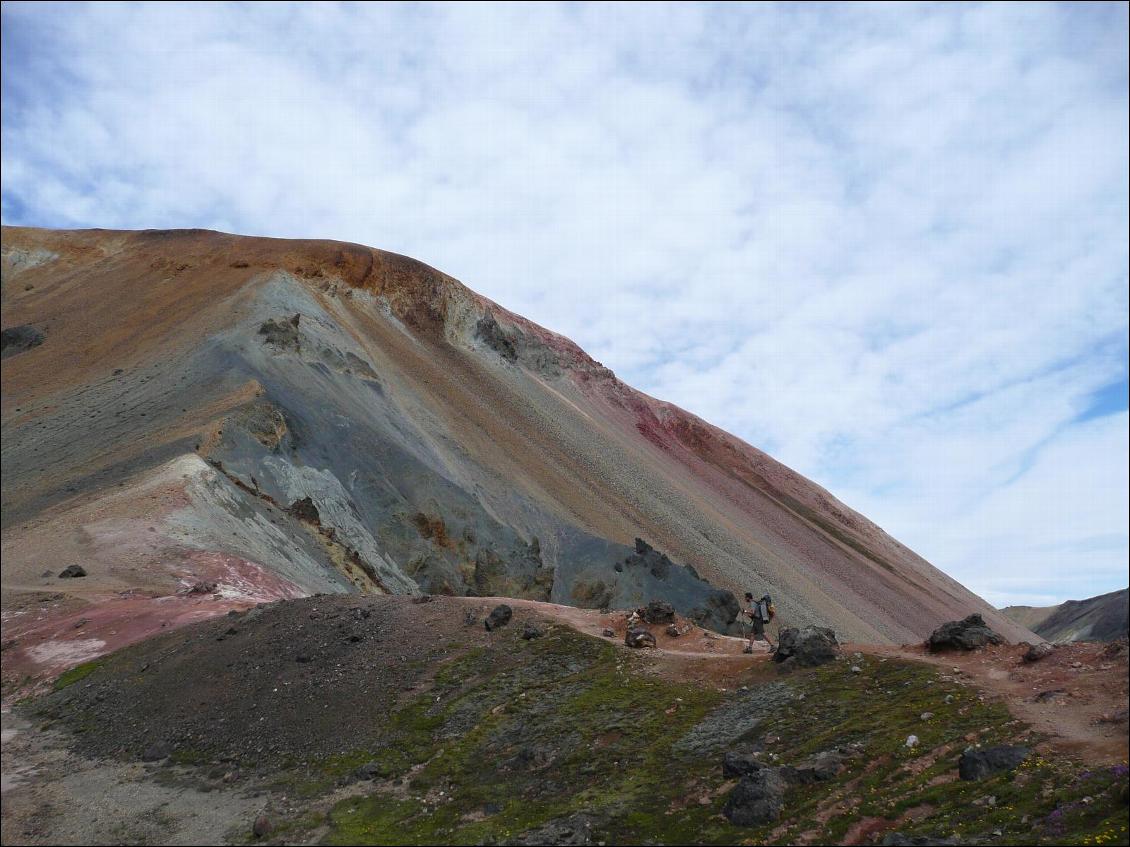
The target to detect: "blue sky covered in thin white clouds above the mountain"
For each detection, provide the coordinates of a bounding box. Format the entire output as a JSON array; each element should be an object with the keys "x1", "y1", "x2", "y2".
[{"x1": 0, "y1": 2, "x2": 1130, "y2": 605}]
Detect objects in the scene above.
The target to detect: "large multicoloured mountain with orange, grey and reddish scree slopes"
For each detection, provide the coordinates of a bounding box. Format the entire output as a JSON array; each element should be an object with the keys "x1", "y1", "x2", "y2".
[{"x1": 2, "y1": 227, "x2": 1031, "y2": 674}]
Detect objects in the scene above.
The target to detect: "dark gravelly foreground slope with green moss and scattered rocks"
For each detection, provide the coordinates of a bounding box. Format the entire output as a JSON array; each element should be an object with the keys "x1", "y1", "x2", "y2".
[{"x1": 3, "y1": 595, "x2": 1128, "y2": 844}]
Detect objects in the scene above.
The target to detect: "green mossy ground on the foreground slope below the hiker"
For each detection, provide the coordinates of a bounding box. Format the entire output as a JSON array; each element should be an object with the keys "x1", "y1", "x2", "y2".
[{"x1": 258, "y1": 628, "x2": 1128, "y2": 844}]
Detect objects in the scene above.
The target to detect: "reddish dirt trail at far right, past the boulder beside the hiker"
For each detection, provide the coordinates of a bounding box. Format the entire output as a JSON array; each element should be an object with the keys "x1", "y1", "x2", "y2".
[{"x1": 846, "y1": 641, "x2": 1128, "y2": 765}]
